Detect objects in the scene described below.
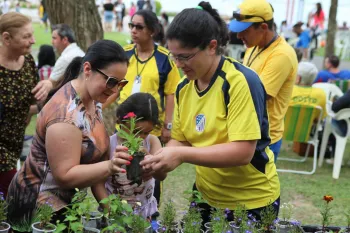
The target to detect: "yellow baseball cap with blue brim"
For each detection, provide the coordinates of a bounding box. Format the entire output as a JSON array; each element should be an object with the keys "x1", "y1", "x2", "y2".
[{"x1": 229, "y1": 0, "x2": 273, "y2": 32}]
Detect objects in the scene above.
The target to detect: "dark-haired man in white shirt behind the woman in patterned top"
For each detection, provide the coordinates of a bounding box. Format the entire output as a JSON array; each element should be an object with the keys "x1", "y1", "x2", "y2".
[{"x1": 50, "y1": 24, "x2": 85, "y2": 85}]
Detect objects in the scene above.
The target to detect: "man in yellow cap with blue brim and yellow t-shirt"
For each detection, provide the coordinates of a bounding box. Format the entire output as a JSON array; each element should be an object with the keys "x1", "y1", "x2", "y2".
[{"x1": 229, "y1": 0, "x2": 298, "y2": 161}]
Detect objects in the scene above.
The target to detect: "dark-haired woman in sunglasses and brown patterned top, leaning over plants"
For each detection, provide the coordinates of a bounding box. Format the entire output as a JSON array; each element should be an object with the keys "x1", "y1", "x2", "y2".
[{"x1": 7, "y1": 40, "x2": 133, "y2": 230}]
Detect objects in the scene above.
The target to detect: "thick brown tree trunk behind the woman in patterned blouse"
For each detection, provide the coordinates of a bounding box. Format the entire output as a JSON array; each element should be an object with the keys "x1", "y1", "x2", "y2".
[{"x1": 45, "y1": 0, "x2": 103, "y2": 51}]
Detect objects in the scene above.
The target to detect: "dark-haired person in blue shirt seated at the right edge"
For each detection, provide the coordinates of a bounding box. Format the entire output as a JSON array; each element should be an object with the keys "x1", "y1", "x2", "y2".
[{"x1": 314, "y1": 55, "x2": 350, "y2": 83}]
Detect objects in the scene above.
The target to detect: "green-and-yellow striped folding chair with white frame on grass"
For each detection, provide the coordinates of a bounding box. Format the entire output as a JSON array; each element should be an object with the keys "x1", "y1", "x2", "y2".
[{"x1": 277, "y1": 105, "x2": 323, "y2": 175}]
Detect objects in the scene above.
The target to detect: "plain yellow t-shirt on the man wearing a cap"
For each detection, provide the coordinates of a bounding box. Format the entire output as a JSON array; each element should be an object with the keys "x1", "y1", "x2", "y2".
[{"x1": 243, "y1": 37, "x2": 298, "y2": 144}]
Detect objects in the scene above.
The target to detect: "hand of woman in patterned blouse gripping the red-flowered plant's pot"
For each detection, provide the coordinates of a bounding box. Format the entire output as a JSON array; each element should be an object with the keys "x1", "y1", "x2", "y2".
[{"x1": 108, "y1": 146, "x2": 133, "y2": 175}]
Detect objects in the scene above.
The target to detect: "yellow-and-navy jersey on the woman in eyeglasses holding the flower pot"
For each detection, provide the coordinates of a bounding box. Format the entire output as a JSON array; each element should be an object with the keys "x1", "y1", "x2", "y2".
[{"x1": 171, "y1": 57, "x2": 280, "y2": 209}]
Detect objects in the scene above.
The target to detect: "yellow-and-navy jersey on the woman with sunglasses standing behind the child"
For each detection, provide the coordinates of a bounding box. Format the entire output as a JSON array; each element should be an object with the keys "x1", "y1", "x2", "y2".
[{"x1": 118, "y1": 44, "x2": 180, "y2": 136}]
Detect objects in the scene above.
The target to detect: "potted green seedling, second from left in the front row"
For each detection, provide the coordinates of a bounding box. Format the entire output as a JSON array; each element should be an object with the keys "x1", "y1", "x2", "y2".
[{"x1": 32, "y1": 202, "x2": 56, "y2": 233}]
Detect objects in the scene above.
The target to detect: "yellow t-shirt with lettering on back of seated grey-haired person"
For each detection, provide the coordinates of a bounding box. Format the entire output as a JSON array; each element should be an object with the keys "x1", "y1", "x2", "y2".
[{"x1": 289, "y1": 85, "x2": 327, "y2": 118}]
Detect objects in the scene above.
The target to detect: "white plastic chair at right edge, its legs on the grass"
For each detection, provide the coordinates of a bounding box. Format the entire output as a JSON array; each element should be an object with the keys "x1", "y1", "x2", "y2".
[{"x1": 318, "y1": 108, "x2": 350, "y2": 179}]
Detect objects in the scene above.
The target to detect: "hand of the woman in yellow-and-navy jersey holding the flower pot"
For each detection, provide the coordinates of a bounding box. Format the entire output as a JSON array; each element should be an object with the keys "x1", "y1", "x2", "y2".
[{"x1": 140, "y1": 147, "x2": 182, "y2": 173}]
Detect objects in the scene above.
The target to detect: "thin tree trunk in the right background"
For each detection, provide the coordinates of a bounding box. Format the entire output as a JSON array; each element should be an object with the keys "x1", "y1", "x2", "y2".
[{"x1": 324, "y1": 0, "x2": 338, "y2": 65}]
